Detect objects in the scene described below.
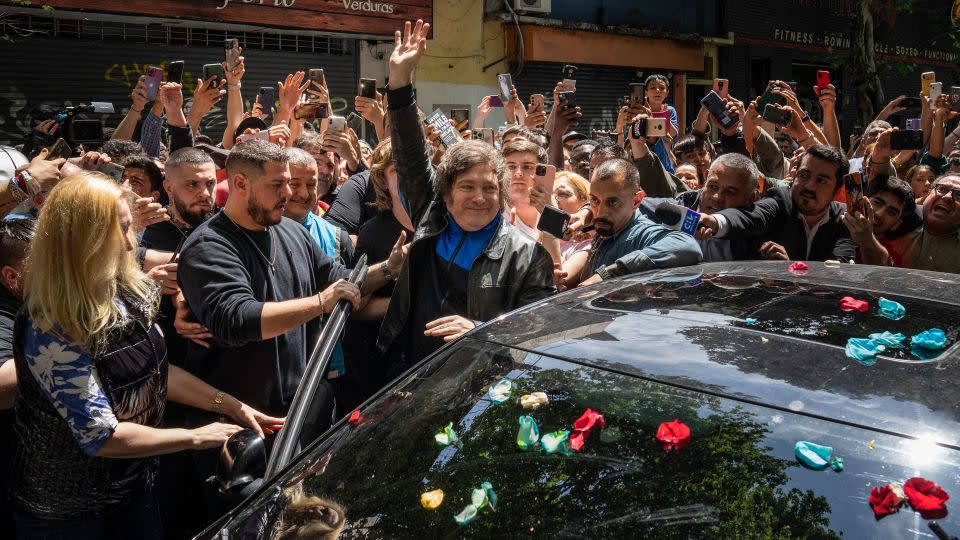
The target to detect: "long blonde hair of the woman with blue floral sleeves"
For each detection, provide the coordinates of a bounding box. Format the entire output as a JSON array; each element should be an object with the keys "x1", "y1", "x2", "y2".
[{"x1": 25, "y1": 172, "x2": 157, "y2": 354}]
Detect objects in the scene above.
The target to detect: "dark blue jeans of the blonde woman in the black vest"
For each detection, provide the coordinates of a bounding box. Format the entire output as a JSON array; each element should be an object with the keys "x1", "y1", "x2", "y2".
[{"x1": 14, "y1": 493, "x2": 163, "y2": 540}]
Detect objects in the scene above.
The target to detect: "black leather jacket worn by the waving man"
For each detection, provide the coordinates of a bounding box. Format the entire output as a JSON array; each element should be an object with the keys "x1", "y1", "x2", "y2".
[{"x1": 377, "y1": 87, "x2": 556, "y2": 351}]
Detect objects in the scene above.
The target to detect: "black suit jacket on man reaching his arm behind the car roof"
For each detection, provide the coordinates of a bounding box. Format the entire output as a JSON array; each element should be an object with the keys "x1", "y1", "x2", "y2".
[{"x1": 719, "y1": 187, "x2": 857, "y2": 262}]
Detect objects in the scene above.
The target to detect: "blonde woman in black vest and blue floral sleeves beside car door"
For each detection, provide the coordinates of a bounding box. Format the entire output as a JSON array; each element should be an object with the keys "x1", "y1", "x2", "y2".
[{"x1": 12, "y1": 173, "x2": 283, "y2": 539}]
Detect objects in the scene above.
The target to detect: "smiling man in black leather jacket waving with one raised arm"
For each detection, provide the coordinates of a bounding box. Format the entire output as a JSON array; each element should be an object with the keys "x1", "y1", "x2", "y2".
[{"x1": 377, "y1": 21, "x2": 556, "y2": 371}]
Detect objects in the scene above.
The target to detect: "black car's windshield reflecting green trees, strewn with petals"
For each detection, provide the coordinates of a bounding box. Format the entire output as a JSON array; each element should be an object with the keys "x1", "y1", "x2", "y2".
[{"x1": 214, "y1": 338, "x2": 960, "y2": 539}]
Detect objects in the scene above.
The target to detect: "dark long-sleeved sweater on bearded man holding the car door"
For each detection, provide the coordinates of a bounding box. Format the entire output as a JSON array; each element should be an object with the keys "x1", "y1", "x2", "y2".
[{"x1": 178, "y1": 211, "x2": 349, "y2": 416}]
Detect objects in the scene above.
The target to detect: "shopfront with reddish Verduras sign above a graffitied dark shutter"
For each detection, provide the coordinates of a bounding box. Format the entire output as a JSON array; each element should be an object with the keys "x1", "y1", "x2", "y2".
[{"x1": 0, "y1": 0, "x2": 433, "y2": 144}]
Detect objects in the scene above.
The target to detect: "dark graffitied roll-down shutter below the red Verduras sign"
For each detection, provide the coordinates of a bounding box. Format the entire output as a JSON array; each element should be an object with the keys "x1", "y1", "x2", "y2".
[{"x1": 0, "y1": 38, "x2": 359, "y2": 144}]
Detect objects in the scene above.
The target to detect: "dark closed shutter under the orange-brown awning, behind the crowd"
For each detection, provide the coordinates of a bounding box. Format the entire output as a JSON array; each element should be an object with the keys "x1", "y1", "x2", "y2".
[{"x1": 511, "y1": 62, "x2": 660, "y2": 135}]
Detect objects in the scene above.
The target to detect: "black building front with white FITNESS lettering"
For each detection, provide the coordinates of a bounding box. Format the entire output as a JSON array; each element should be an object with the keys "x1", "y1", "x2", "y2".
[{"x1": 719, "y1": 0, "x2": 960, "y2": 136}]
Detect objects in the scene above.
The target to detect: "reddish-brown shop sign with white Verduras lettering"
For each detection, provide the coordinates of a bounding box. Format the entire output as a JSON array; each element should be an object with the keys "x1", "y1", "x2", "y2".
[{"x1": 36, "y1": 0, "x2": 433, "y2": 38}]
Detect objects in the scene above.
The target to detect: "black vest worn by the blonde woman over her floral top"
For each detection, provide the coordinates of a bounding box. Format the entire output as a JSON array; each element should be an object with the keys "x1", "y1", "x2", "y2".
[{"x1": 12, "y1": 304, "x2": 167, "y2": 519}]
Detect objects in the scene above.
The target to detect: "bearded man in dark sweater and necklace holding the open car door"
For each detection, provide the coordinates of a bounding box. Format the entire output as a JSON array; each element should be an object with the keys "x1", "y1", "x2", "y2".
[{"x1": 178, "y1": 139, "x2": 403, "y2": 514}]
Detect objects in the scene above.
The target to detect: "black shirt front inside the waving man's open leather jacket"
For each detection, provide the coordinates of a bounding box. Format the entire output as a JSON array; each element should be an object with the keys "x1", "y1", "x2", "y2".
[{"x1": 402, "y1": 249, "x2": 470, "y2": 365}]
